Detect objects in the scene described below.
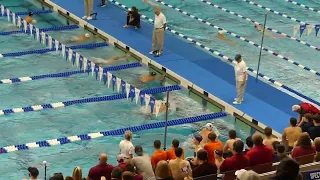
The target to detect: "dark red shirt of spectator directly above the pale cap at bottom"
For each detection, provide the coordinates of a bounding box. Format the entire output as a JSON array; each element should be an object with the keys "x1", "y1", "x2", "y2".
[{"x1": 220, "y1": 154, "x2": 249, "y2": 172}]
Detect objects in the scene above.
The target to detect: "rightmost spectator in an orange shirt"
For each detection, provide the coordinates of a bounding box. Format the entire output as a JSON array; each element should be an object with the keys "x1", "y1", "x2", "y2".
[{"x1": 204, "y1": 132, "x2": 223, "y2": 163}]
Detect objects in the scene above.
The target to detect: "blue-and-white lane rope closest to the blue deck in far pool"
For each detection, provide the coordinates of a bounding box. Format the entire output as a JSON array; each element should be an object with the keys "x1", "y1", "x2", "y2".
[{"x1": 108, "y1": 0, "x2": 320, "y2": 106}]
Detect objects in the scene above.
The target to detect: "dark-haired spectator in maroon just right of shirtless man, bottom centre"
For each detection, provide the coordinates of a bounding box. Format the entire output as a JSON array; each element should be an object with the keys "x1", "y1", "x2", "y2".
[{"x1": 192, "y1": 149, "x2": 217, "y2": 179}]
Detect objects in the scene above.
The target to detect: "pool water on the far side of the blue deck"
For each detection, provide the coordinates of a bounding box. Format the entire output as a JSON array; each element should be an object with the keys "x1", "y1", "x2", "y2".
[{"x1": 114, "y1": 0, "x2": 320, "y2": 101}]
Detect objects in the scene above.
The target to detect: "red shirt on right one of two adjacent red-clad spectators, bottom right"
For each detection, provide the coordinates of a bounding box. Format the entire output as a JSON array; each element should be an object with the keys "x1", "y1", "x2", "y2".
[{"x1": 247, "y1": 144, "x2": 273, "y2": 166}]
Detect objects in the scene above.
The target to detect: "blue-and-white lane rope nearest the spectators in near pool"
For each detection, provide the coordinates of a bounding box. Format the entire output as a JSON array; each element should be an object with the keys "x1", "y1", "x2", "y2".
[{"x1": 0, "y1": 112, "x2": 227, "y2": 154}]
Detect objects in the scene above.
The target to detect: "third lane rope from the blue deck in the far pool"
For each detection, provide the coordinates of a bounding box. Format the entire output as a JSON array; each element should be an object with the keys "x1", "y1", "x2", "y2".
[{"x1": 200, "y1": 0, "x2": 320, "y2": 51}]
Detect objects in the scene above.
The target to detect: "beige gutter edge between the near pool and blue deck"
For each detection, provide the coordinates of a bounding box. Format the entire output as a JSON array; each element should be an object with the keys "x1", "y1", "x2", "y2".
[{"x1": 34, "y1": 0, "x2": 281, "y2": 138}]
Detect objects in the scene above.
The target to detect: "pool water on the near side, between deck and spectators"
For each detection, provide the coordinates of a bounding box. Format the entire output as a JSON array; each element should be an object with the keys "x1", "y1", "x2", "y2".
[{"x1": 0, "y1": 1, "x2": 252, "y2": 179}]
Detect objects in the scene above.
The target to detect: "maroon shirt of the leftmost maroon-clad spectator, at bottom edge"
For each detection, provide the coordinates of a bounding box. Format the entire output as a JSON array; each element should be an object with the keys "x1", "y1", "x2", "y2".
[{"x1": 88, "y1": 164, "x2": 114, "y2": 180}]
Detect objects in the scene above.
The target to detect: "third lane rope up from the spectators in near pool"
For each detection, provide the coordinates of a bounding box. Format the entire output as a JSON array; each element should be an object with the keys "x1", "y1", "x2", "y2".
[{"x1": 0, "y1": 63, "x2": 142, "y2": 84}]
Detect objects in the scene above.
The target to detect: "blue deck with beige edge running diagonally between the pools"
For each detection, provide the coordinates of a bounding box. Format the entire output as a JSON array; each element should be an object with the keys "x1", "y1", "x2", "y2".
[{"x1": 44, "y1": 0, "x2": 301, "y2": 135}]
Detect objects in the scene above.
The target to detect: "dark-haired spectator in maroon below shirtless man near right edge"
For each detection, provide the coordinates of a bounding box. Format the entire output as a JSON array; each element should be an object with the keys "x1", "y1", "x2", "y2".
[{"x1": 291, "y1": 133, "x2": 316, "y2": 158}]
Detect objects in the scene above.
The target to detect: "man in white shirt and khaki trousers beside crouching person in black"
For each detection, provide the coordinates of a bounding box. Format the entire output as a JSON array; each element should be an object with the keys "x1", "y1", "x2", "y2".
[{"x1": 150, "y1": 6, "x2": 167, "y2": 56}]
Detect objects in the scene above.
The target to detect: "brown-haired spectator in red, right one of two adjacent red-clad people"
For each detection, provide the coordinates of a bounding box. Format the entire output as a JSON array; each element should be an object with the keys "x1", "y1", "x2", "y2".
[{"x1": 247, "y1": 134, "x2": 273, "y2": 166}]
